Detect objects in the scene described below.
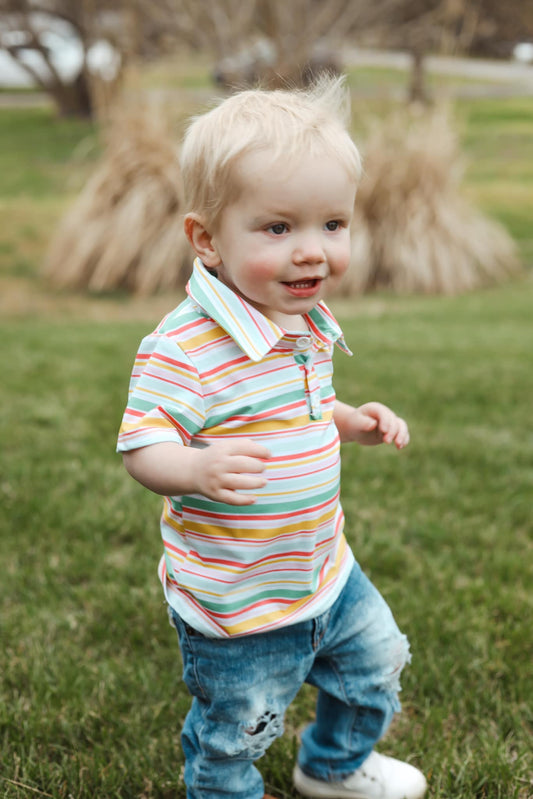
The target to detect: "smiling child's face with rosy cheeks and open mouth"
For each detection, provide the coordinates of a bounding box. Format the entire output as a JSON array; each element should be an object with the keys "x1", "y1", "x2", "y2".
[{"x1": 209, "y1": 152, "x2": 356, "y2": 328}]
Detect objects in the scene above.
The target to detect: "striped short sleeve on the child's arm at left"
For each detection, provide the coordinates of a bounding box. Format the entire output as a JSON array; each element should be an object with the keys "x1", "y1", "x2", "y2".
[{"x1": 117, "y1": 333, "x2": 205, "y2": 452}]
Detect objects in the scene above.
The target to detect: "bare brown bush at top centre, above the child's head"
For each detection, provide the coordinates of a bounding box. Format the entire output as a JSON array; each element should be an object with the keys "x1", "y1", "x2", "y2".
[{"x1": 132, "y1": 0, "x2": 399, "y2": 86}]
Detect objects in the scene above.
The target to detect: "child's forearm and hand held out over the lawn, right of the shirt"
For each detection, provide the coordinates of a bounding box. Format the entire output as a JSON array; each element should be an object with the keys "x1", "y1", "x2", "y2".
[{"x1": 333, "y1": 400, "x2": 409, "y2": 449}]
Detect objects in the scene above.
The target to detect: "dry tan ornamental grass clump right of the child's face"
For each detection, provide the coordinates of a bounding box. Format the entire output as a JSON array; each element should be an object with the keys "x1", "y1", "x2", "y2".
[{"x1": 342, "y1": 104, "x2": 519, "y2": 294}]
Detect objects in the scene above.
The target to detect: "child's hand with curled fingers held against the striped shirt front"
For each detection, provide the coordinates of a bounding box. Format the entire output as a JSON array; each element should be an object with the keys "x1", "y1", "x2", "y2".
[{"x1": 193, "y1": 438, "x2": 270, "y2": 505}]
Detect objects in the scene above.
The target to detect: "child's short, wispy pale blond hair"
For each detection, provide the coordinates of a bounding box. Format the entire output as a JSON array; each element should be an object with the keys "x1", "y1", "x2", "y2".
[{"x1": 181, "y1": 77, "x2": 361, "y2": 229}]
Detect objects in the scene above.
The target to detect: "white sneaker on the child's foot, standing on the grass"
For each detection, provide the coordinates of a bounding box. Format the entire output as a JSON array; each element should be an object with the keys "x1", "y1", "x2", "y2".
[{"x1": 292, "y1": 752, "x2": 427, "y2": 799}]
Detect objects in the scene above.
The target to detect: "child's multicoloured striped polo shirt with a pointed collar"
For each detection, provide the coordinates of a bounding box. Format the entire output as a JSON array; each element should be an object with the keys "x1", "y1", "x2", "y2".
[{"x1": 118, "y1": 259, "x2": 353, "y2": 638}]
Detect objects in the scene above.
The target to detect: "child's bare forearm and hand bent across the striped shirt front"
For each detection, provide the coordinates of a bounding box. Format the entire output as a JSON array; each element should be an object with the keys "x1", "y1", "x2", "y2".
[{"x1": 123, "y1": 439, "x2": 270, "y2": 505}]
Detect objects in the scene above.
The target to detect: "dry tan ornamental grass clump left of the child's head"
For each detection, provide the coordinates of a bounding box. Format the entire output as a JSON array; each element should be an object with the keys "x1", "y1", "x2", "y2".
[{"x1": 45, "y1": 107, "x2": 192, "y2": 295}]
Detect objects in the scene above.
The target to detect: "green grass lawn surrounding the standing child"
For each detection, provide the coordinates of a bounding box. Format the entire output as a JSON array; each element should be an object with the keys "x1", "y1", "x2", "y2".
[{"x1": 0, "y1": 59, "x2": 533, "y2": 799}]
